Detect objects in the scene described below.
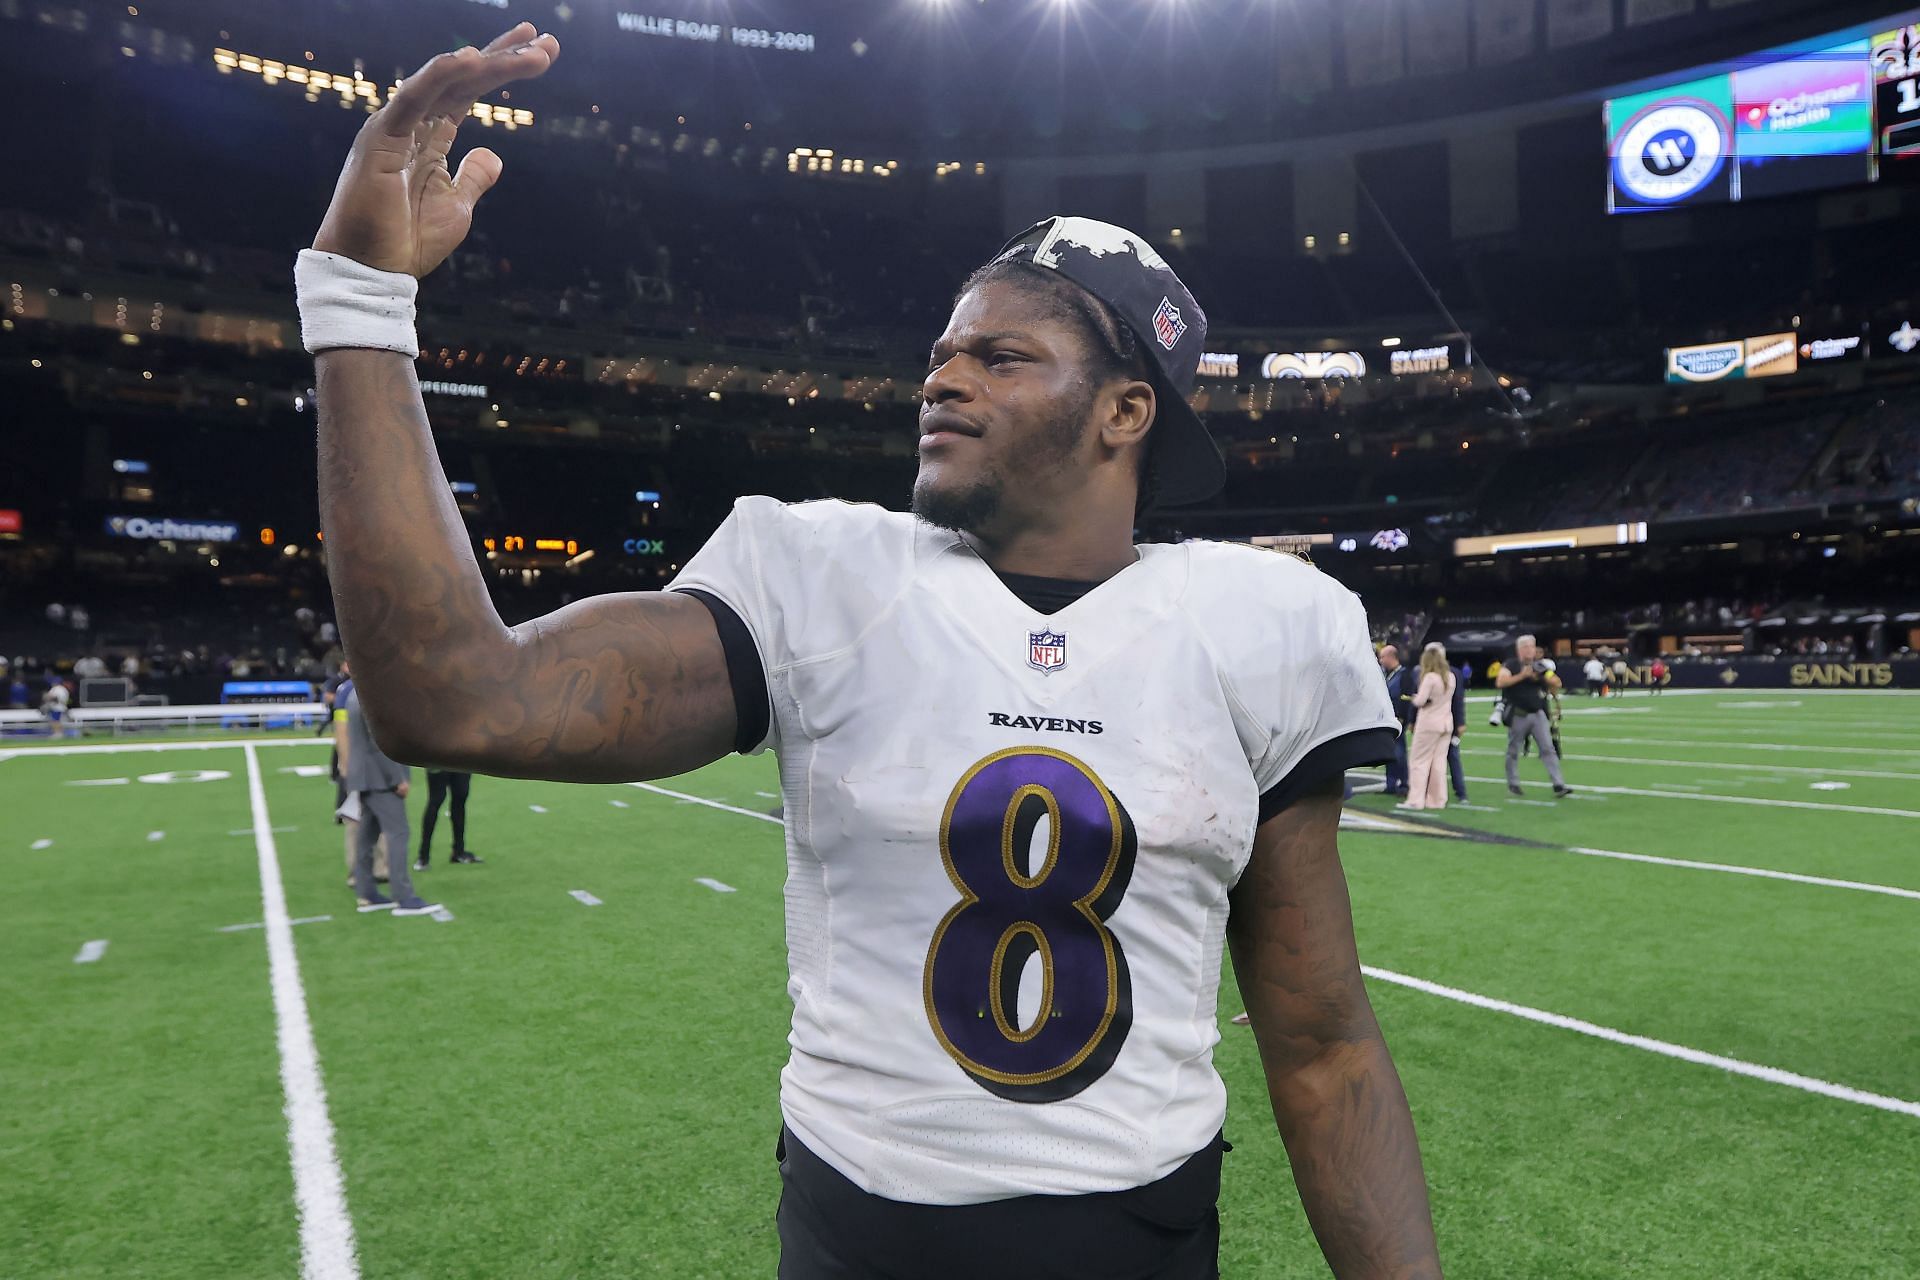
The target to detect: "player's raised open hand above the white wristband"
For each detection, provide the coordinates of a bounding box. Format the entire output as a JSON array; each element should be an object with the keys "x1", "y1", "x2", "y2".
[{"x1": 313, "y1": 23, "x2": 561, "y2": 278}]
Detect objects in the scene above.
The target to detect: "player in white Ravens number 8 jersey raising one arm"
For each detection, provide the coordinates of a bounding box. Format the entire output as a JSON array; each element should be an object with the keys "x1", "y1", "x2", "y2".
[{"x1": 298, "y1": 25, "x2": 1440, "y2": 1280}]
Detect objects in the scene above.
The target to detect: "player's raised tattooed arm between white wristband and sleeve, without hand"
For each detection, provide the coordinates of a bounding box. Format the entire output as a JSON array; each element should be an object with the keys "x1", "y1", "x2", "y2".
[{"x1": 317, "y1": 351, "x2": 733, "y2": 781}]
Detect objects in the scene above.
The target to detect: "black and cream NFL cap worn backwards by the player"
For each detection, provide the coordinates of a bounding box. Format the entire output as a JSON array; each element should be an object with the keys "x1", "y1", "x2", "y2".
[{"x1": 993, "y1": 215, "x2": 1227, "y2": 507}]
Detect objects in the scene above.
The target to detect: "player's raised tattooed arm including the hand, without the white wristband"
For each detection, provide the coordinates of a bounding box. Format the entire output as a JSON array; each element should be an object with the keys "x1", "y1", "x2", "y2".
[{"x1": 313, "y1": 23, "x2": 733, "y2": 781}]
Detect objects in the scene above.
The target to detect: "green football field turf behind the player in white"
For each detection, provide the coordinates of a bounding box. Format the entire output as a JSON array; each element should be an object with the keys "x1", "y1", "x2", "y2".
[{"x1": 0, "y1": 693, "x2": 1920, "y2": 1280}]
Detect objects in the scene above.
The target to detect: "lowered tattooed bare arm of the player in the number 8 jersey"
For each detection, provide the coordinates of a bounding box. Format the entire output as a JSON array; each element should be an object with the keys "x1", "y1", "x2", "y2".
[{"x1": 1227, "y1": 785, "x2": 1440, "y2": 1280}]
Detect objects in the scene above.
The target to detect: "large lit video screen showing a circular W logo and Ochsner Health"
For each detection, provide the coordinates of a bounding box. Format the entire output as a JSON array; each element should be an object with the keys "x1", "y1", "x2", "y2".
[{"x1": 1605, "y1": 10, "x2": 1920, "y2": 213}]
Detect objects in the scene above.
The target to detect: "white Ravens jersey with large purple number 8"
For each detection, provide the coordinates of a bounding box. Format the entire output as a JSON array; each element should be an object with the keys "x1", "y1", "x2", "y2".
[{"x1": 674, "y1": 497, "x2": 1396, "y2": 1205}]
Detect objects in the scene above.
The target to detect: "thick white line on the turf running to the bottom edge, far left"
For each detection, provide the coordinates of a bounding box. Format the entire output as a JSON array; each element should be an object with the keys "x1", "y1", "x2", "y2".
[{"x1": 244, "y1": 743, "x2": 359, "y2": 1280}]
